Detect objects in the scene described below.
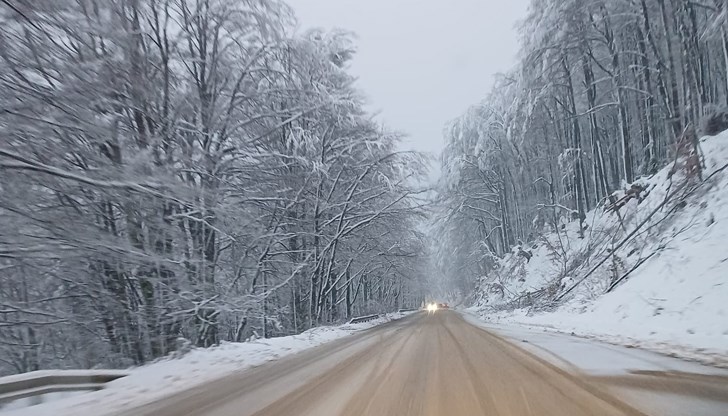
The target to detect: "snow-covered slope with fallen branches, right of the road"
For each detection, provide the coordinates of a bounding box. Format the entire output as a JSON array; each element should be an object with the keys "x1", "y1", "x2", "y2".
[{"x1": 475, "y1": 132, "x2": 728, "y2": 363}]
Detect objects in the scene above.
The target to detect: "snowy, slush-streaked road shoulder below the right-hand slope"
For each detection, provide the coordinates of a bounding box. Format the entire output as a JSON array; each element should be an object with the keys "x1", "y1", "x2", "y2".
[{"x1": 462, "y1": 312, "x2": 728, "y2": 416}]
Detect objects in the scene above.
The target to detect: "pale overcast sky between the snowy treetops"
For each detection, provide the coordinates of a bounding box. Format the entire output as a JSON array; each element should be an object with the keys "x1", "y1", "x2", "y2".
[{"x1": 288, "y1": 0, "x2": 528, "y2": 158}]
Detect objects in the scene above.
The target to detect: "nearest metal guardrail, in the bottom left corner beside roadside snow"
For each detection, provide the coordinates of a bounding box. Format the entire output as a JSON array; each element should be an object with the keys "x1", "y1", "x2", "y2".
[{"x1": 0, "y1": 370, "x2": 129, "y2": 408}]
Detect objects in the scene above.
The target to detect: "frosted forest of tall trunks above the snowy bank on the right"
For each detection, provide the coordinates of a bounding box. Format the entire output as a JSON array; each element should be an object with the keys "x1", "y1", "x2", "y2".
[{"x1": 433, "y1": 0, "x2": 728, "y2": 293}]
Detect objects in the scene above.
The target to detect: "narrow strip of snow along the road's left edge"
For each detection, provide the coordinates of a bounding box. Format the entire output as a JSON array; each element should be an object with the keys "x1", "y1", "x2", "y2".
[{"x1": 0, "y1": 313, "x2": 406, "y2": 416}]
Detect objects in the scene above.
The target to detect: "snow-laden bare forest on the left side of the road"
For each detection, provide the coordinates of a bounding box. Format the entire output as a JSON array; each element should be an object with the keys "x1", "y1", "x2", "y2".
[{"x1": 0, "y1": 0, "x2": 427, "y2": 375}]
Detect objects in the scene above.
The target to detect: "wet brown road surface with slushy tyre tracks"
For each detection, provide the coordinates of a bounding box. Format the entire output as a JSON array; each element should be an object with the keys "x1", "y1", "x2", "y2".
[{"x1": 125, "y1": 310, "x2": 728, "y2": 416}]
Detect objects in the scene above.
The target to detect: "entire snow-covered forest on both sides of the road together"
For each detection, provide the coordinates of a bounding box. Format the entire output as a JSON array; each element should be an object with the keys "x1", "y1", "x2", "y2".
[{"x1": 5, "y1": 0, "x2": 728, "y2": 375}]
